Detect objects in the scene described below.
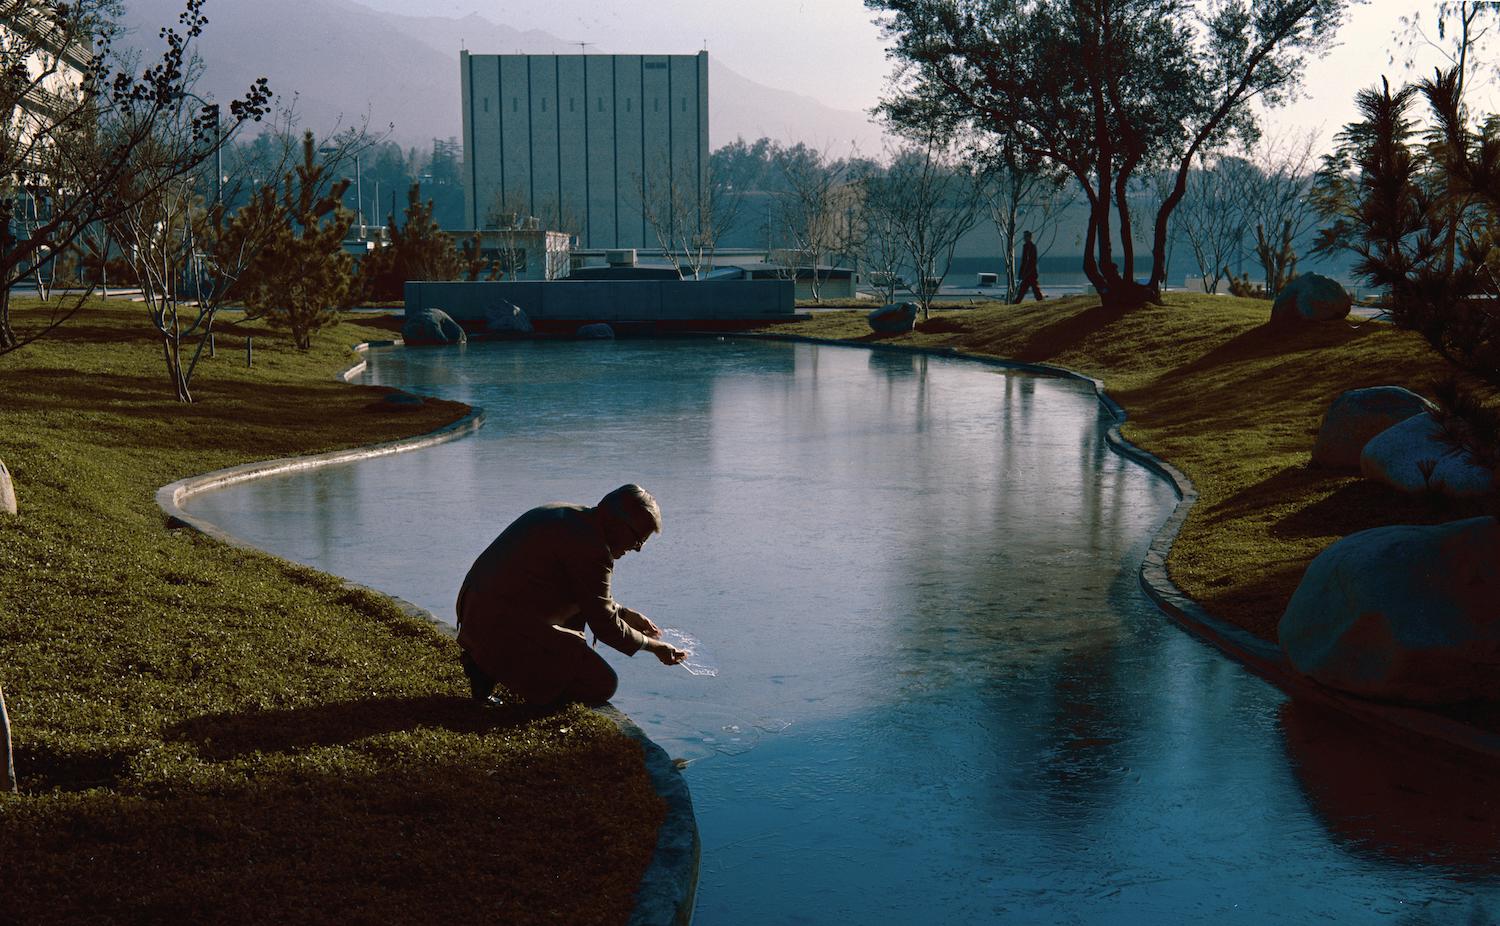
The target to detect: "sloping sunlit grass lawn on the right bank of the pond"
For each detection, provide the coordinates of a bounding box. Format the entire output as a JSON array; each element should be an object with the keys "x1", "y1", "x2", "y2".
[{"x1": 767, "y1": 294, "x2": 1484, "y2": 639}]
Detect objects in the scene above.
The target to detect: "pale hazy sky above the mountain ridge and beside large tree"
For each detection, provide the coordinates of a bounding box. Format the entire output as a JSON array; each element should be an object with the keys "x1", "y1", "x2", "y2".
[{"x1": 356, "y1": 0, "x2": 1500, "y2": 155}]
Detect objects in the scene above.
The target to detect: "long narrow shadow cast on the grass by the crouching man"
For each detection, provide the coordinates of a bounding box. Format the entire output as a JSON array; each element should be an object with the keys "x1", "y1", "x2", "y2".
[{"x1": 164, "y1": 695, "x2": 552, "y2": 761}]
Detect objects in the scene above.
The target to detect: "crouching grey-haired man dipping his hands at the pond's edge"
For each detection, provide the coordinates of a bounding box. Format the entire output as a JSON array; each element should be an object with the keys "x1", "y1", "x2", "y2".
[{"x1": 458, "y1": 485, "x2": 687, "y2": 704}]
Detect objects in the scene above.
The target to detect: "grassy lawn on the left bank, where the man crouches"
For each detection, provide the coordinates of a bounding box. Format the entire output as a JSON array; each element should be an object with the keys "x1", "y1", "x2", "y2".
[{"x1": 0, "y1": 300, "x2": 663, "y2": 924}]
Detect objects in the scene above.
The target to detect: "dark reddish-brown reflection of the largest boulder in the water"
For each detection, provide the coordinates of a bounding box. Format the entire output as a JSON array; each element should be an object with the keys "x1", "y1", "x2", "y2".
[{"x1": 1280, "y1": 701, "x2": 1500, "y2": 876}]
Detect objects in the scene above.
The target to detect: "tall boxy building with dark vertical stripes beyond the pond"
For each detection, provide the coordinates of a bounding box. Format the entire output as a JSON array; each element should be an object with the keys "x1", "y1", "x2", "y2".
[{"x1": 459, "y1": 51, "x2": 708, "y2": 249}]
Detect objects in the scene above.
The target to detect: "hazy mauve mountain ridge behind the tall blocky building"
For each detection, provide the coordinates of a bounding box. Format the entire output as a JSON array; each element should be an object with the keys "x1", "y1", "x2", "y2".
[{"x1": 125, "y1": 0, "x2": 882, "y2": 156}]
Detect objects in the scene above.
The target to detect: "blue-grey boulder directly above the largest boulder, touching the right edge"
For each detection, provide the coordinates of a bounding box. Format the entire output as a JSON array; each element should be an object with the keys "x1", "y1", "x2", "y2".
[{"x1": 1359, "y1": 414, "x2": 1496, "y2": 498}]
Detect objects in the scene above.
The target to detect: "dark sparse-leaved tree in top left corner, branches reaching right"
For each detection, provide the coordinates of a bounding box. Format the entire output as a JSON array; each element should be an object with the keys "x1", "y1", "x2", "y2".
[{"x1": 0, "y1": 0, "x2": 270, "y2": 354}]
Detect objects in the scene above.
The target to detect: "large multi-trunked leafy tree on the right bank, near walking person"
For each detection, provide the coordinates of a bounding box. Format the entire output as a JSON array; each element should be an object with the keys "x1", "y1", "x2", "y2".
[{"x1": 866, "y1": 0, "x2": 1346, "y2": 308}]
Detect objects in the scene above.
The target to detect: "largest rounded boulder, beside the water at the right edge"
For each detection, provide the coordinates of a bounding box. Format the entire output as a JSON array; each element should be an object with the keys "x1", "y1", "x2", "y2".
[{"x1": 1277, "y1": 518, "x2": 1500, "y2": 704}]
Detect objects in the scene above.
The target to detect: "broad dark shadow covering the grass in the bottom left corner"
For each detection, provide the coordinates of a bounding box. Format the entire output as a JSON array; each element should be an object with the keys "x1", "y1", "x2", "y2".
[{"x1": 0, "y1": 735, "x2": 656, "y2": 924}]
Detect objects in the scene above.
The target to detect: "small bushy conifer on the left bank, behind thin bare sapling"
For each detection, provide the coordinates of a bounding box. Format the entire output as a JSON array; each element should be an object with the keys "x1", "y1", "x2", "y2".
[{"x1": 240, "y1": 132, "x2": 357, "y2": 350}]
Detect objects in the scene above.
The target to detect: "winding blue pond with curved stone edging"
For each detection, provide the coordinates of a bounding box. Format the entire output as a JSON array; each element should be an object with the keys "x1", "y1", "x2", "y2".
[{"x1": 188, "y1": 339, "x2": 1500, "y2": 926}]
